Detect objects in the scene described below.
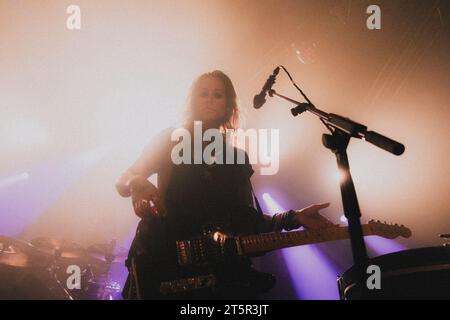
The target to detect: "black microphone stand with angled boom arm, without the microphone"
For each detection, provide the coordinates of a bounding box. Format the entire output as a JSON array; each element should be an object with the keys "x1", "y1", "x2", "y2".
[{"x1": 268, "y1": 89, "x2": 405, "y2": 298}]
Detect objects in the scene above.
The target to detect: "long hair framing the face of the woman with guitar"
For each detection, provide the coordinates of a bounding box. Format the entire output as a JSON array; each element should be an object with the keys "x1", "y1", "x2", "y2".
[{"x1": 183, "y1": 70, "x2": 240, "y2": 132}]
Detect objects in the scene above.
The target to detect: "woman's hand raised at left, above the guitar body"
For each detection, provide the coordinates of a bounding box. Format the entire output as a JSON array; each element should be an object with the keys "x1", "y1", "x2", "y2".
[{"x1": 129, "y1": 176, "x2": 165, "y2": 218}]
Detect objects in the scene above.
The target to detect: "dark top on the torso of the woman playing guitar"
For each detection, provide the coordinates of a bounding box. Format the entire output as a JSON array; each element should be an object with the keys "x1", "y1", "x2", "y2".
[{"x1": 165, "y1": 144, "x2": 264, "y2": 238}]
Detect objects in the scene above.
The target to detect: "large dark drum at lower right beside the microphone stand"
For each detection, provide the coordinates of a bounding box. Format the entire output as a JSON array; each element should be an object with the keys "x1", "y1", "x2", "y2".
[{"x1": 338, "y1": 245, "x2": 450, "y2": 300}]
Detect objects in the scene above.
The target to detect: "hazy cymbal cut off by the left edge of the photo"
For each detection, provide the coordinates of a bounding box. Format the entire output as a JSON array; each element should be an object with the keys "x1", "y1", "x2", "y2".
[{"x1": 0, "y1": 236, "x2": 43, "y2": 267}]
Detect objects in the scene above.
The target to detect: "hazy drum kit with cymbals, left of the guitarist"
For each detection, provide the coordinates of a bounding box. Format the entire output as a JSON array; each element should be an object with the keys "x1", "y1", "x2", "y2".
[{"x1": 0, "y1": 236, "x2": 127, "y2": 300}]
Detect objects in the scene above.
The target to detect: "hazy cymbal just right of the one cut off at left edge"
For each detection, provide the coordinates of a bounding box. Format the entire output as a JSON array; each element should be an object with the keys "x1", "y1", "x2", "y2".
[{"x1": 30, "y1": 237, "x2": 86, "y2": 258}]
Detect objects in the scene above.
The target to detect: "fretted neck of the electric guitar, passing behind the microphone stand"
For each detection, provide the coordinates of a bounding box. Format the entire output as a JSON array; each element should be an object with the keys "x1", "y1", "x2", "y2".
[{"x1": 237, "y1": 224, "x2": 374, "y2": 255}]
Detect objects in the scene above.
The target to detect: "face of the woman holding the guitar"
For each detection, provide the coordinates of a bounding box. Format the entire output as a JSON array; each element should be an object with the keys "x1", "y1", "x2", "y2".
[{"x1": 194, "y1": 77, "x2": 227, "y2": 127}]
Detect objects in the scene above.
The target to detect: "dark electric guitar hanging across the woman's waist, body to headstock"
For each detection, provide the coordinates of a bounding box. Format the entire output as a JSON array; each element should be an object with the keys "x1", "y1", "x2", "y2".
[{"x1": 141, "y1": 216, "x2": 411, "y2": 296}]
